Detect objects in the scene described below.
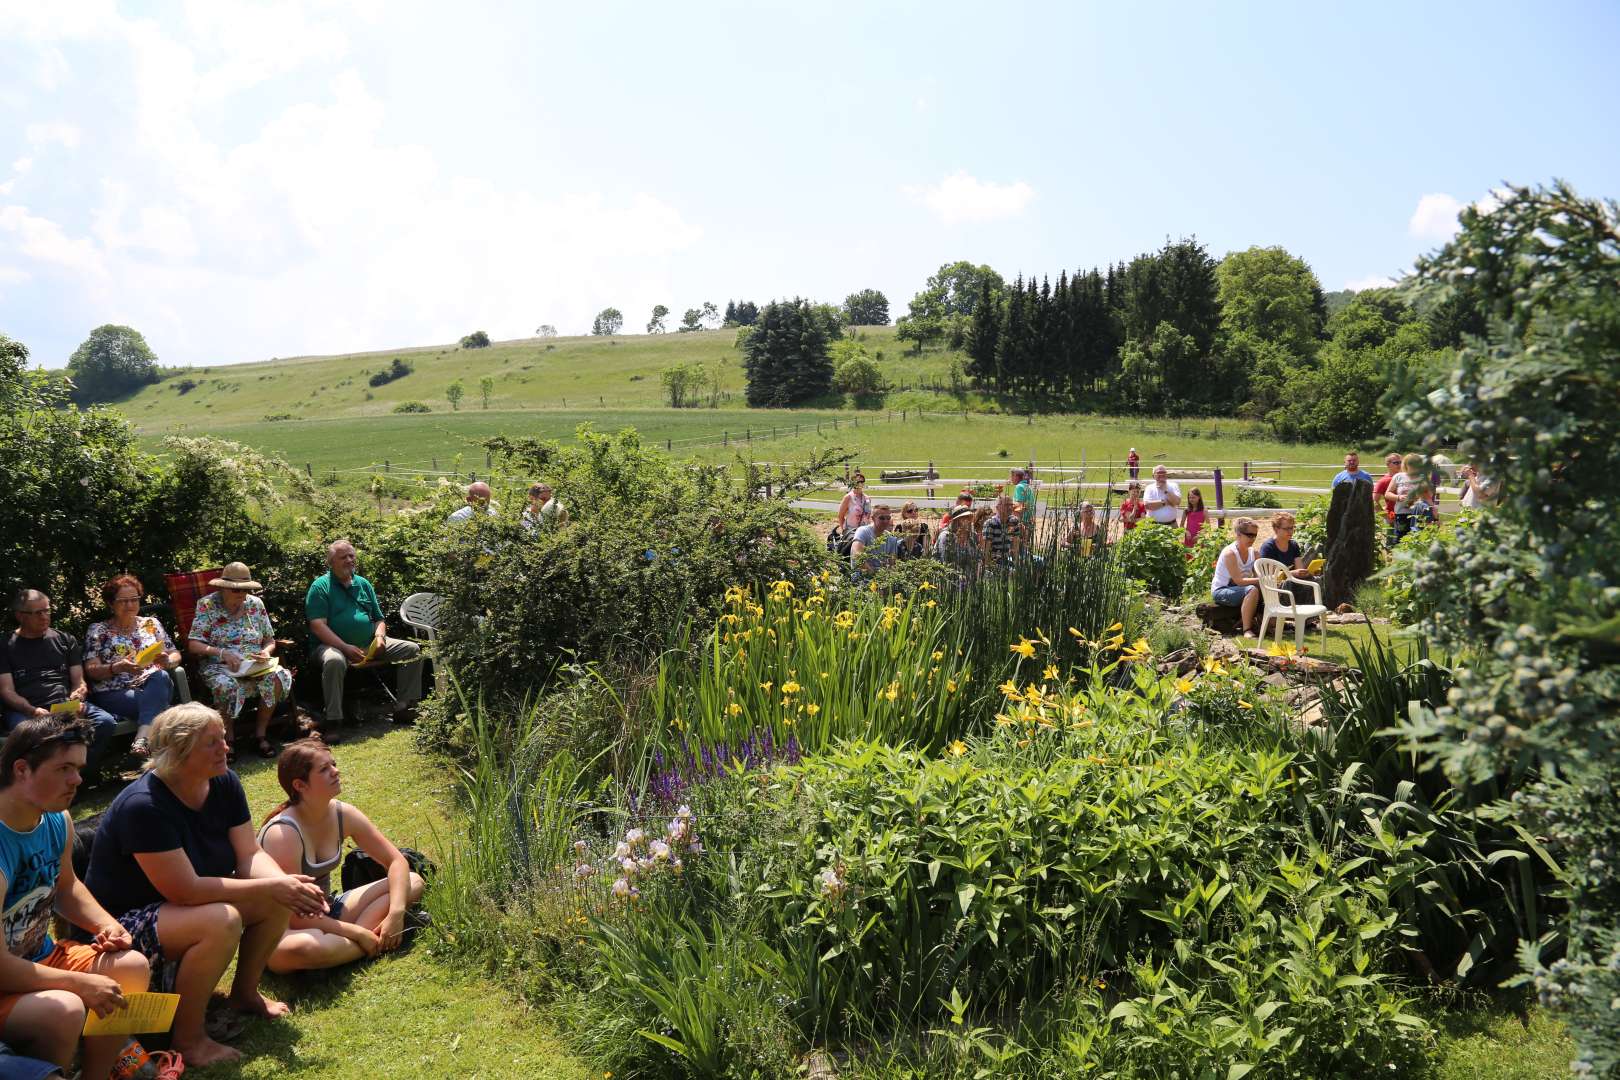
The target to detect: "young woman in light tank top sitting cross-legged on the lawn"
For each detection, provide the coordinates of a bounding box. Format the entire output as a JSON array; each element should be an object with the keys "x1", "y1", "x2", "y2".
[{"x1": 259, "y1": 738, "x2": 423, "y2": 973}]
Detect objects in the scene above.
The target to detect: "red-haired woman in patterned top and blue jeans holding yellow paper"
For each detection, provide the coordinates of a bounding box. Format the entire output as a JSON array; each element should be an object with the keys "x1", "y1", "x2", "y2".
[{"x1": 84, "y1": 573, "x2": 180, "y2": 758}]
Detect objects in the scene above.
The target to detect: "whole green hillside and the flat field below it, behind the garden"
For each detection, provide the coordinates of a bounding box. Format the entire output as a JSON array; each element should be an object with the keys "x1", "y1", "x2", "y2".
[{"x1": 117, "y1": 327, "x2": 1343, "y2": 504}]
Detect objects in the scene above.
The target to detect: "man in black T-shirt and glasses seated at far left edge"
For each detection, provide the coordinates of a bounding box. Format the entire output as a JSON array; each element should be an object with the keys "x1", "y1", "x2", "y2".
[{"x1": 0, "y1": 589, "x2": 118, "y2": 774}]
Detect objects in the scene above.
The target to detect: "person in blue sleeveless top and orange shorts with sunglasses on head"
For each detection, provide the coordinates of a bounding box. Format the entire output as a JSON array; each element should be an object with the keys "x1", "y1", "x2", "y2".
[{"x1": 0, "y1": 716, "x2": 151, "y2": 1080}]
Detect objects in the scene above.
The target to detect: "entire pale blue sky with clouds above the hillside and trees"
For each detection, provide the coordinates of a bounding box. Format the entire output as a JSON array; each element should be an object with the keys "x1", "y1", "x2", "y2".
[{"x1": 0, "y1": 0, "x2": 1620, "y2": 366}]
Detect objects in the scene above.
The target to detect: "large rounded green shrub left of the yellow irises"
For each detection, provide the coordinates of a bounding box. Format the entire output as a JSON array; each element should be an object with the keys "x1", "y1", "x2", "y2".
[{"x1": 428, "y1": 427, "x2": 826, "y2": 735}]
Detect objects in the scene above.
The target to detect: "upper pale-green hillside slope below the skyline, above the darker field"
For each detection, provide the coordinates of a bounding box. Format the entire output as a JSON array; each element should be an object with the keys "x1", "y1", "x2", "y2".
[{"x1": 118, "y1": 327, "x2": 953, "y2": 434}]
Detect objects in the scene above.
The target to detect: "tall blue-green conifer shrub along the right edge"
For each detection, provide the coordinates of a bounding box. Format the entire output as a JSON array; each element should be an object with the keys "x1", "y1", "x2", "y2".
[{"x1": 1395, "y1": 183, "x2": 1620, "y2": 1075}]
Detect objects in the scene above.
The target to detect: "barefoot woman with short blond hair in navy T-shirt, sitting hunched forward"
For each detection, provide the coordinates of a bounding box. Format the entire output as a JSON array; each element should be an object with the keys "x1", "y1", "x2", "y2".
[{"x1": 84, "y1": 701, "x2": 326, "y2": 1067}]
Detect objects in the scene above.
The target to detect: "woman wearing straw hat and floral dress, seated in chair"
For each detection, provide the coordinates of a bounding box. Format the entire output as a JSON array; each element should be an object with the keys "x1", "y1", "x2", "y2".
[{"x1": 186, "y1": 562, "x2": 293, "y2": 758}]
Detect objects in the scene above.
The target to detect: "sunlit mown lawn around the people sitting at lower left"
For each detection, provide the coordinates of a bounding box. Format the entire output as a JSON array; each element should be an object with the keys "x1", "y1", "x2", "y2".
[{"x1": 73, "y1": 724, "x2": 601, "y2": 1080}]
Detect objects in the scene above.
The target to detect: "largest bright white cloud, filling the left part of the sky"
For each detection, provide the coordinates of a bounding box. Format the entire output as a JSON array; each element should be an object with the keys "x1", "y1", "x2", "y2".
[{"x1": 0, "y1": 0, "x2": 701, "y2": 363}]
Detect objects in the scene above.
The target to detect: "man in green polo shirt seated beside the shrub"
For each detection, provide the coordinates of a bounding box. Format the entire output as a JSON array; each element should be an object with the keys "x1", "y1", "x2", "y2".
[{"x1": 305, "y1": 539, "x2": 421, "y2": 725}]
